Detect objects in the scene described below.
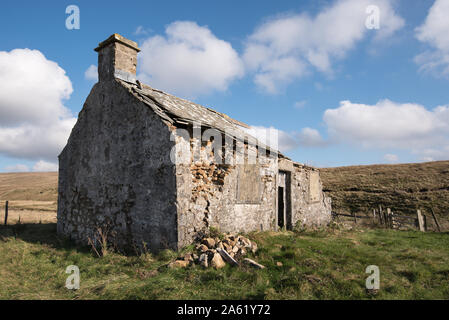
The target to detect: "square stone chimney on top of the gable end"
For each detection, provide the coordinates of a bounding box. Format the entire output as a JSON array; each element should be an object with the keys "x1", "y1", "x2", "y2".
[{"x1": 95, "y1": 33, "x2": 140, "y2": 83}]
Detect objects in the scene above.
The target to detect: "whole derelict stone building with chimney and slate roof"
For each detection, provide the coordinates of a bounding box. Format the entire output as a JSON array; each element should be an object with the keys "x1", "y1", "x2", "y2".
[{"x1": 57, "y1": 34, "x2": 331, "y2": 251}]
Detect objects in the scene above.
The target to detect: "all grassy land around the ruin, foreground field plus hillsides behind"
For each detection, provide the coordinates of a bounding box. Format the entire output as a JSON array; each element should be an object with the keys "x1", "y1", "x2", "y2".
[{"x1": 0, "y1": 168, "x2": 449, "y2": 299}]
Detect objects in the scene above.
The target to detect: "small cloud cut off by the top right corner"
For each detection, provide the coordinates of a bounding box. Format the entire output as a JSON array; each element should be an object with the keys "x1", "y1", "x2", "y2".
[{"x1": 415, "y1": 0, "x2": 449, "y2": 76}]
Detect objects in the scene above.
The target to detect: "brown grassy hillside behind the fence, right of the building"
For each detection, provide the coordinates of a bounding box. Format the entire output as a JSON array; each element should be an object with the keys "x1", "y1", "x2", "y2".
[{"x1": 320, "y1": 161, "x2": 449, "y2": 217}]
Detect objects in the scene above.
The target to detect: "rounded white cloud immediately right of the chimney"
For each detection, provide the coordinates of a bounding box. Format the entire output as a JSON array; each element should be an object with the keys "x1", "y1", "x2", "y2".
[{"x1": 138, "y1": 21, "x2": 244, "y2": 97}]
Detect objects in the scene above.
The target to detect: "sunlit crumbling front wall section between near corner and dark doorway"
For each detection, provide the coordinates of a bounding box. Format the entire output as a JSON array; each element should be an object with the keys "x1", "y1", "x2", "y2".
[{"x1": 176, "y1": 132, "x2": 277, "y2": 247}]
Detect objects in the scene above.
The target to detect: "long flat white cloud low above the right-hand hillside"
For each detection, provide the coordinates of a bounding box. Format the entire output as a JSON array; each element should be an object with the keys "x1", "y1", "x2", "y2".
[{"x1": 323, "y1": 100, "x2": 449, "y2": 158}]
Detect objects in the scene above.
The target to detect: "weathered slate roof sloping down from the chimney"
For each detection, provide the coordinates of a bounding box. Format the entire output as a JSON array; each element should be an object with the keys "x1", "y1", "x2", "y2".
[{"x1": 117, "y1": 79, "x2": 285, "y2": 157}]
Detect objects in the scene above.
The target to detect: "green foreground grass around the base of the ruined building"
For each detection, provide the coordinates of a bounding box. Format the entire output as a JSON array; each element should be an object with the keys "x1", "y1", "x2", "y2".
[{"x1": 0, "y1": 224, "x2": 449, "y2": 299}]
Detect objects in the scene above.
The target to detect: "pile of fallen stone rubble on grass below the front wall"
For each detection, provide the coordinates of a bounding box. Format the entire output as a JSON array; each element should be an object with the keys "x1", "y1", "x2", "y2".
[{"x1": 170, "y1": 235, "x2": 265, "y2": 269}]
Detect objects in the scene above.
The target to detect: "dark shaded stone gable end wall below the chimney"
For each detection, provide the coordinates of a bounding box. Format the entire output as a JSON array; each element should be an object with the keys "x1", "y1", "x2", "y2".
[{"x1": 57, "y1": 80, "x2": 177, "y2": 251}]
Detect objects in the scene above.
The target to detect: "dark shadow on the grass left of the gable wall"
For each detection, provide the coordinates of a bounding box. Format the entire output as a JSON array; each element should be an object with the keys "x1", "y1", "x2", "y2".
[{"x1": 0, "y1": 223, "x2": 90, "y2": 252}]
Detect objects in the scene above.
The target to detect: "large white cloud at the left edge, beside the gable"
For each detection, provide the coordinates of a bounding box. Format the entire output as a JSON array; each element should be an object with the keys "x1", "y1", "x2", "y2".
[{"x1": 0, "y1": 49, "x2": 76, "y2": 161}]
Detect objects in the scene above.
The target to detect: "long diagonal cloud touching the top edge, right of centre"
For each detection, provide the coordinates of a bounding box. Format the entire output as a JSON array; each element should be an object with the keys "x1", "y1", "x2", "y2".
[{"x1": 243, "y1": 0, "x2": 404, "y2": 94}]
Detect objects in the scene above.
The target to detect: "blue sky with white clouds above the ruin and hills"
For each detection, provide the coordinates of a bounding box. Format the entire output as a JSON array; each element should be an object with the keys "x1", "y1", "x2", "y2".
[{"x1": 0, "y1": 0, "x2": 449, "y2": 172}]
